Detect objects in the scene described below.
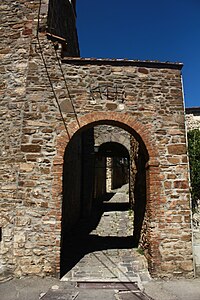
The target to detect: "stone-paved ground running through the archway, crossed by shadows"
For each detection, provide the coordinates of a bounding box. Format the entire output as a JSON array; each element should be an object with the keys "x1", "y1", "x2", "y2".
[{"x1": 62, "y1": 185, "x2": 150, "y2": 284}]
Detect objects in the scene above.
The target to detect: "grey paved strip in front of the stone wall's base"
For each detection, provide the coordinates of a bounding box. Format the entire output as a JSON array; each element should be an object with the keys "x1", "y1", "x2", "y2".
[{"x1": 0, "y1": 277, "x2": 200, "y2": 300}]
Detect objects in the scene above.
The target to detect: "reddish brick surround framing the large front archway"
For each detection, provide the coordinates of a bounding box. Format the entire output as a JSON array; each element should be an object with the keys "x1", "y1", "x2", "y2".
[{"x1": 52, "y1": 112, "x2": 163, "y2": 274}]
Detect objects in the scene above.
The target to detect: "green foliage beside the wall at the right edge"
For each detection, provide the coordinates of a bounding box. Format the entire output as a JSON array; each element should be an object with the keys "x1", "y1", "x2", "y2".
[{"x1": 188, "y1": 129, "x2": 200, "y2": 210}]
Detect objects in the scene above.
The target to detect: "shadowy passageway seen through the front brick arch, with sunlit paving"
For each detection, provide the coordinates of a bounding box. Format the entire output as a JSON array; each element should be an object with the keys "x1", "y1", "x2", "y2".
[{"x1": 60, "y1": 122, "x2": 148, "y2": 280}]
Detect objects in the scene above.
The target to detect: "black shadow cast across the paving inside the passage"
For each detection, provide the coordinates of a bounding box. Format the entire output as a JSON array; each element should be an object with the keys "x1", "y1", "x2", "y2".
[{"x1": 61, "y1": 193, "x2": 133, "y2": 277}]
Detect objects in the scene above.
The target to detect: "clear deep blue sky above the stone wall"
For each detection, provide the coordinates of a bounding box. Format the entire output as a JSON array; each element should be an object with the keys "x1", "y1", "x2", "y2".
[{"x1": 77, "y1": 0, "x2": 200, "y2": 107}]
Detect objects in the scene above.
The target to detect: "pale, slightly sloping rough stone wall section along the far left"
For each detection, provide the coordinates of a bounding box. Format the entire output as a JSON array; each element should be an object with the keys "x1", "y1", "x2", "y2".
[{"x1": 0, "y1": 1, "x2": 44, "y2": 271}]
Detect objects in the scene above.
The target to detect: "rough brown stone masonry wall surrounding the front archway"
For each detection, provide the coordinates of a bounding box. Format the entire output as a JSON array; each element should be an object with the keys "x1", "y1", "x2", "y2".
[{"x1": 0, "y1": 0, "x2": 193, "y2": 277}]
